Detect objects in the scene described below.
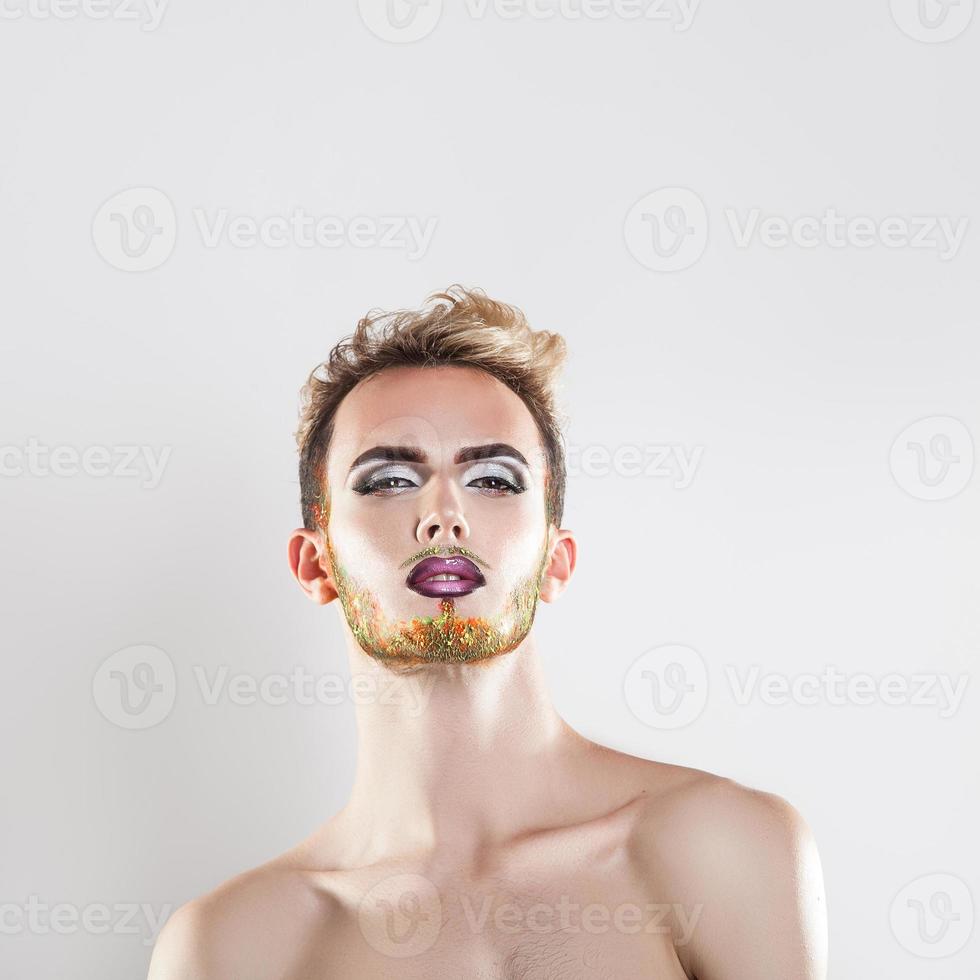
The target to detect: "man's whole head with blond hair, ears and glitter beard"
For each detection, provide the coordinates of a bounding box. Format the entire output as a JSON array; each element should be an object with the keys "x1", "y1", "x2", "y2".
[{"x1": 289, "y1": 286, "x2": 575, "y2": 669}]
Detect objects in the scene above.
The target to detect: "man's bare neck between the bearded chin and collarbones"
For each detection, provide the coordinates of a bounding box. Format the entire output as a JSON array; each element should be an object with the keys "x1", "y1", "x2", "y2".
[{"x1": 338, "y1": 634, "x2": 585, "y2": 863}]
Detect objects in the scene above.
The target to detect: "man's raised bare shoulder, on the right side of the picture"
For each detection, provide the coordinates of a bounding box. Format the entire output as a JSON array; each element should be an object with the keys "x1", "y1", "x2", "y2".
[{"x1": 600, "y1": 748, "x2": 827, "y2": 980}]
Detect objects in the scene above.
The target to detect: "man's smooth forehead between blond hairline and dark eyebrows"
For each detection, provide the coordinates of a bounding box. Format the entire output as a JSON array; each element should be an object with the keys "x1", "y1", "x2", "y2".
[{"x1": 328, "y1": 365, "x2": 544, "y2": 472}]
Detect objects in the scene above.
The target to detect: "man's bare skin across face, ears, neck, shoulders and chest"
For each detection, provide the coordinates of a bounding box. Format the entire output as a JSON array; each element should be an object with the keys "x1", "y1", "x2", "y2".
[{"x1": 150, "y1": 367, "x2": 826, "y2": 980}]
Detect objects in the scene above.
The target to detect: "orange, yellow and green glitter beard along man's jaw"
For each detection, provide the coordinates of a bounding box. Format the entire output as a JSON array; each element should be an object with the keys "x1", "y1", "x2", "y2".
[{"x1": 313, "y1": 491, "x2": 548, "y2": 667}]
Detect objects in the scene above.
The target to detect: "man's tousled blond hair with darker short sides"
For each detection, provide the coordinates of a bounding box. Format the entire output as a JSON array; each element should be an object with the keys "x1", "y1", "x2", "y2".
[{"x1": 295, "y1": 285, "x2": 566, "y2": 531}]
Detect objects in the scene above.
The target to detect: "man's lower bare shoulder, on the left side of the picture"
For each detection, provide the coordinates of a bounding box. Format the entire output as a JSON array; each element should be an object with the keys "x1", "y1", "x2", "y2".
[{"x1": 149, "y1": 856, "x2": 336, "y2": 980}]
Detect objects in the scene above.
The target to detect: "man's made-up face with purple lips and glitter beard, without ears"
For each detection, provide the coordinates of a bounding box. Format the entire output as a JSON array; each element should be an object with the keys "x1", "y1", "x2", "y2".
[{"x1": 319, "y1": 367, "x2": 552, "y2": 666}]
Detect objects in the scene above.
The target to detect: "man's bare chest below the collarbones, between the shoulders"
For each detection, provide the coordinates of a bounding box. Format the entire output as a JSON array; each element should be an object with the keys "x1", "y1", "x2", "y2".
[{"x1": 302, "y1": 849, "x2": 698, "y2": 980}]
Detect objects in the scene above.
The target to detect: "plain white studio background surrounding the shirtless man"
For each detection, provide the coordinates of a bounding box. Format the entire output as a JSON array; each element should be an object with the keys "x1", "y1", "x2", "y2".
[{"x1": 0, "y1": 0, "x2": 980, "y2": 980}]
